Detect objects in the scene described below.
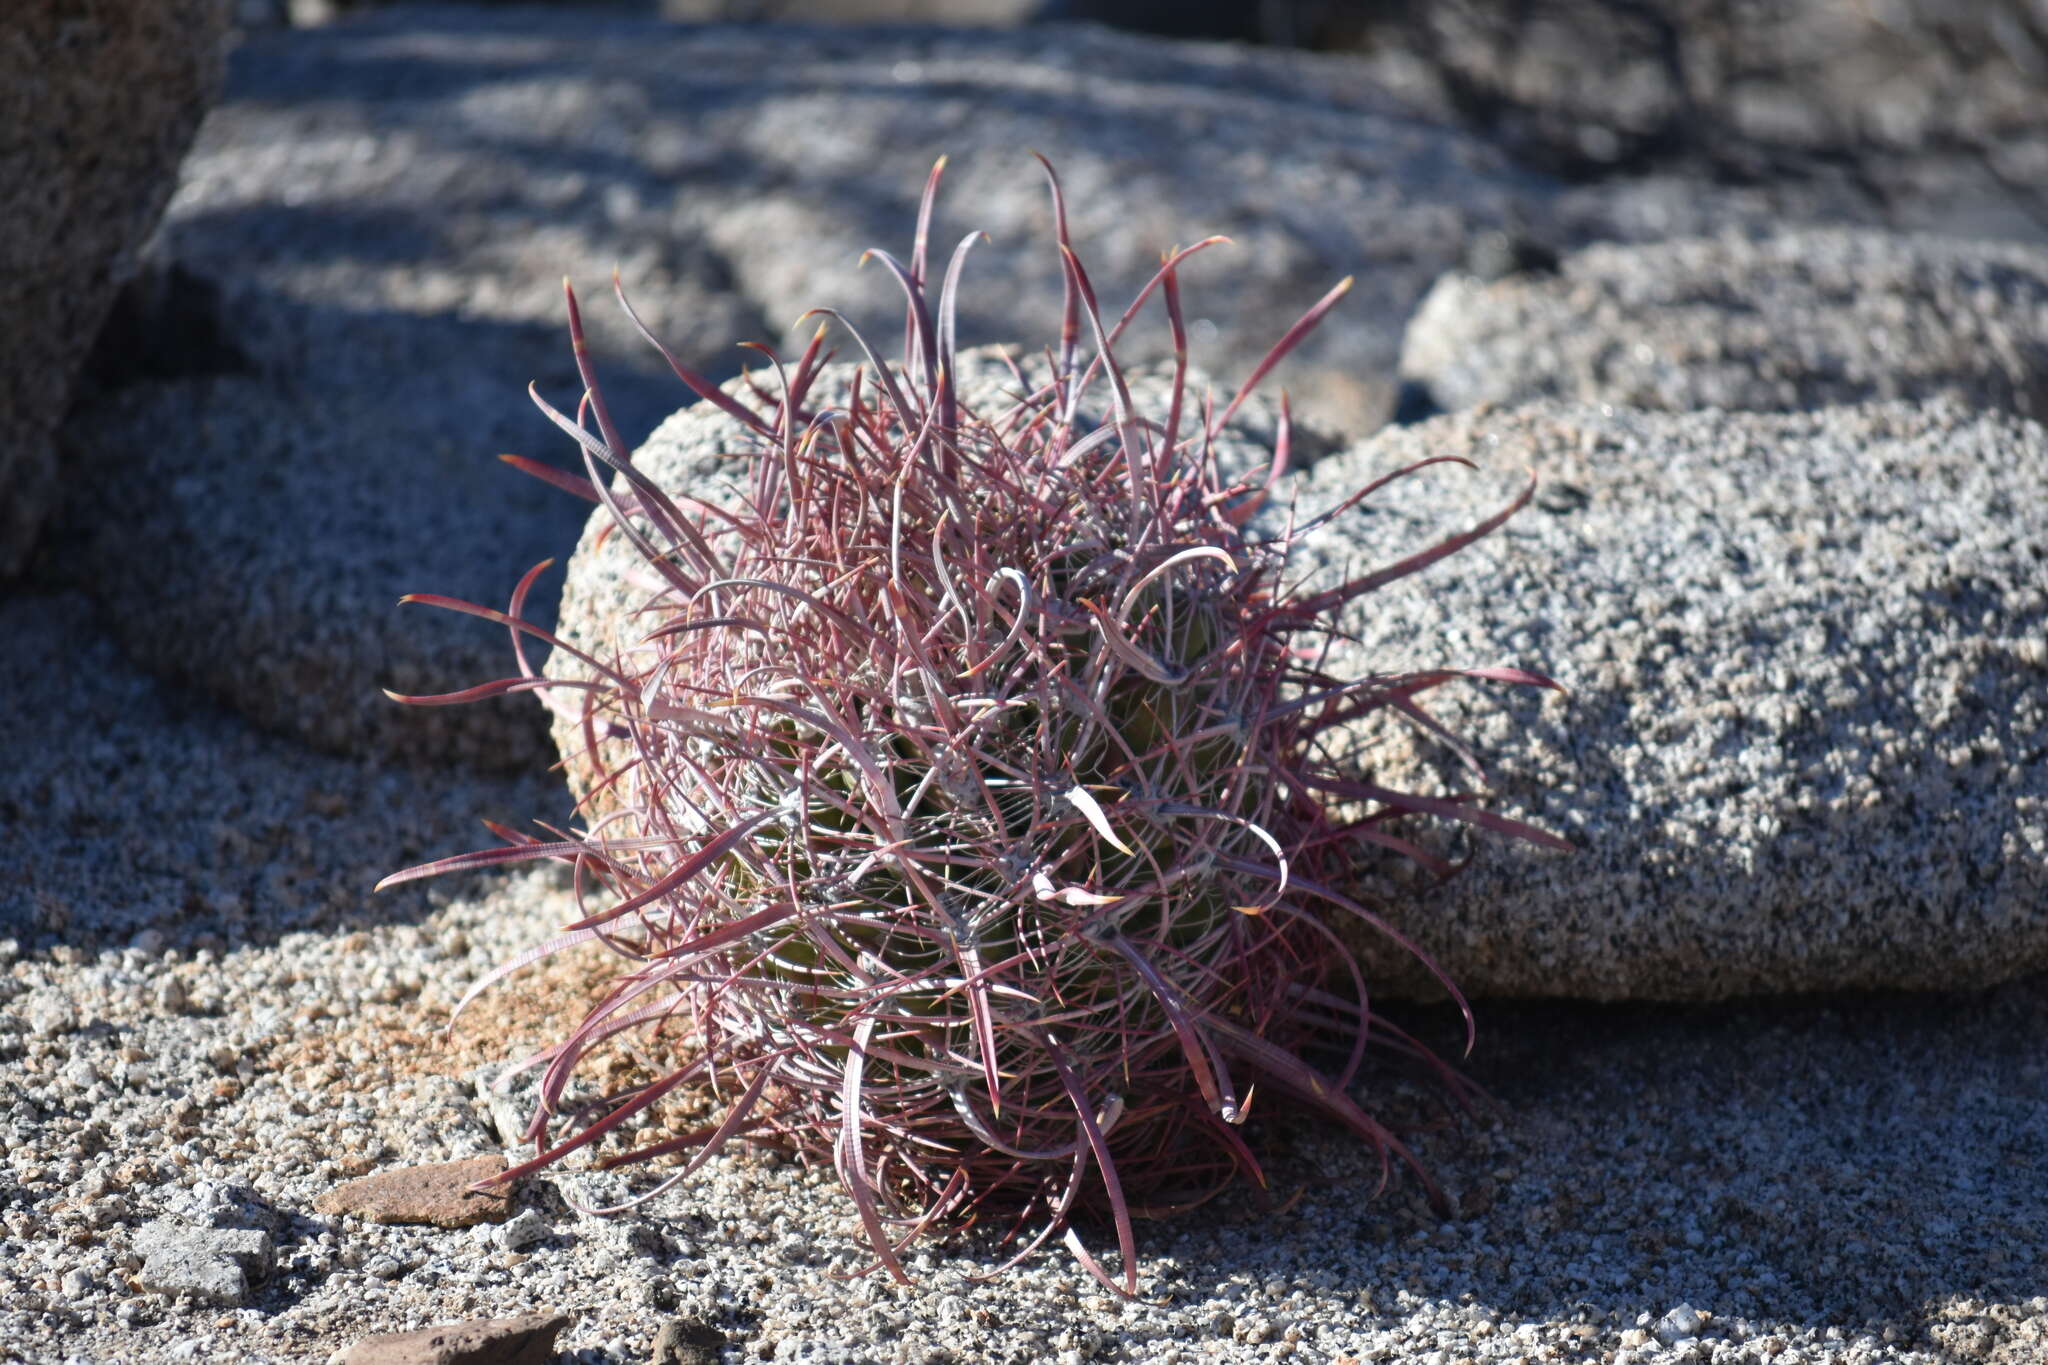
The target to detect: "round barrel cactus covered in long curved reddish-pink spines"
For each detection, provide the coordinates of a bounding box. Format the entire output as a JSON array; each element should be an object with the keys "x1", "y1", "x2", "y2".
[{"x1": 387, "y1": 162, "x2": 1559, "y2": 1293}]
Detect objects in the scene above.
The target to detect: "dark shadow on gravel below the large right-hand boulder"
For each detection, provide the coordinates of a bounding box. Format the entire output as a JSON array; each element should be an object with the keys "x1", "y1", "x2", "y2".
[{"x1": 1151, "y1": 976, "x2": 2048, "y2": 1361}]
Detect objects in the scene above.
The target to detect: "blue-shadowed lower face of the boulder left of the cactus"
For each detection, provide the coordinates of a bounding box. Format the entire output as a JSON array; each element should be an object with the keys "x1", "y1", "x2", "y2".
[{"x1": 53, "y1": 300, "x2": 643, "y2": 769}]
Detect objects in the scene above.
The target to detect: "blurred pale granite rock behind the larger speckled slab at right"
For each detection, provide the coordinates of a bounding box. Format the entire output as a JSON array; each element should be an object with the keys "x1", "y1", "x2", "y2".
[{"x1": 1401, "y1": 229, "x2": 2048, "y2": 420}]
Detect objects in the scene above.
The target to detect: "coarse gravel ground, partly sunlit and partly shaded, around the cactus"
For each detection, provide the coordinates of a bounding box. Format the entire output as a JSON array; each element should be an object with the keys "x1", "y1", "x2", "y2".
[{"x1": 0, "y1": 589, "x2": 2048, "y2": 1365}]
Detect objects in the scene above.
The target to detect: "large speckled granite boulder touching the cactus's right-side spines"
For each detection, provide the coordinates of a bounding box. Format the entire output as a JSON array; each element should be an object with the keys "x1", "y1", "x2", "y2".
[{"x1": 1300, "y1": 403, "x2": 2048, "y2": 999}]
